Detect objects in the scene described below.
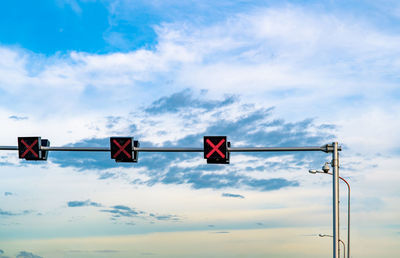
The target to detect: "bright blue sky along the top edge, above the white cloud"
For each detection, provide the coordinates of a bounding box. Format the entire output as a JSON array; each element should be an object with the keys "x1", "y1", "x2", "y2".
[{"x1": 0, "y1": 0, "x2": 398, "y2": 55}]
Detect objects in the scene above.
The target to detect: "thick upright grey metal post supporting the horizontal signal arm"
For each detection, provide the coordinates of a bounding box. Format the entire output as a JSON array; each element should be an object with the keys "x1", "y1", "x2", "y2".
[{"x1": 332, "y1": 142, "x2": 339, "y2": 258}]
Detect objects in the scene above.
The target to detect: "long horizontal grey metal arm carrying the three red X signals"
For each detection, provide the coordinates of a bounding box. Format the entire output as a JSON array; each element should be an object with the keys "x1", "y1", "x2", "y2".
[{"x1": 0, "y1": 144, "x2": 341, "y2": 152}]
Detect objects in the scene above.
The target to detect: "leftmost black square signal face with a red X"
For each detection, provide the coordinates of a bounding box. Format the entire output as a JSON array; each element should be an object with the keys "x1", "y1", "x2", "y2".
[{"x1": 18, "y1": 137, "x2": 42, "y2": 160}]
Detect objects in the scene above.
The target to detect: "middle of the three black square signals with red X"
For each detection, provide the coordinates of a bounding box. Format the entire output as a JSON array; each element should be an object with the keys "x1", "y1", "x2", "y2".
[{"x1": 110, "y1": 137, "x2": 134, "y2": 162}]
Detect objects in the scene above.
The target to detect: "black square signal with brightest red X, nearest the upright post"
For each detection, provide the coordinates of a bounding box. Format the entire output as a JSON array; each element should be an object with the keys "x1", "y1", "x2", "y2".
[{"x1": 204, "y1": 136, "x2": 229, "y2": 164}]
